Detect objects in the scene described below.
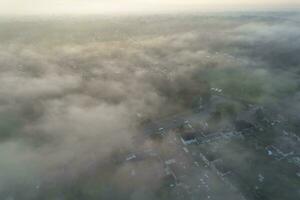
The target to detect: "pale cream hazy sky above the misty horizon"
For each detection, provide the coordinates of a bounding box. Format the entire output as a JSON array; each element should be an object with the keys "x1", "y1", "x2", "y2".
[{"x1": 0, "y1": 0, "x2": 300, "y2": 15}]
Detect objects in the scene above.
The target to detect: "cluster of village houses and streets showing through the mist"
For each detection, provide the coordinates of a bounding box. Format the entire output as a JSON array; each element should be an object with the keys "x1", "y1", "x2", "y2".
[{"x1": 120, "y1": 89, "x2": 300, "y2": 200}]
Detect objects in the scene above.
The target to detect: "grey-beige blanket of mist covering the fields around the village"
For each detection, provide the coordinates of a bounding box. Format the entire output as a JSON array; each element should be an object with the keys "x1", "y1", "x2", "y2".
[{"x1": 0, "y1": 12, "x2": 300, "y2": 200}]
